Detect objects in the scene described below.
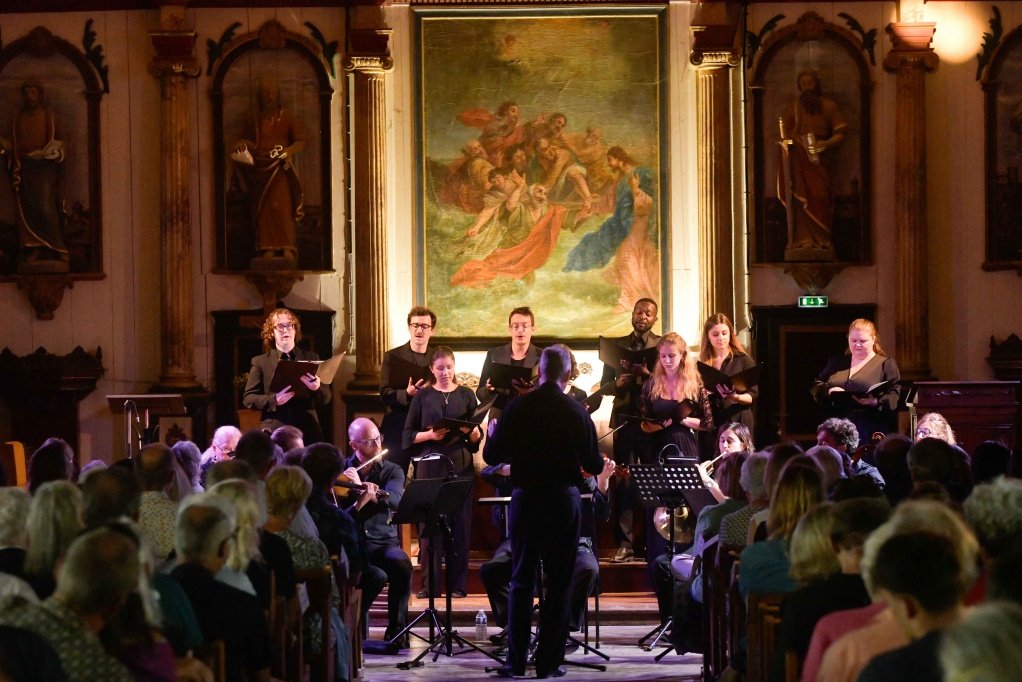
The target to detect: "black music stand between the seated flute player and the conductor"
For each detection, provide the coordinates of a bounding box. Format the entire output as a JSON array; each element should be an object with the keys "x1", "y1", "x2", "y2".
[{"x1": 390, "y1": 478, "x2": 504, "y2": 670}]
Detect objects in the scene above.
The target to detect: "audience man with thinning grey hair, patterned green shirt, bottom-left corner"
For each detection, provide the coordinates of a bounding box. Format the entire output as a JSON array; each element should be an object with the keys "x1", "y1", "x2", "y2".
[{"x1": 0, "y1": 527, "x2": 139, "y2": 682}]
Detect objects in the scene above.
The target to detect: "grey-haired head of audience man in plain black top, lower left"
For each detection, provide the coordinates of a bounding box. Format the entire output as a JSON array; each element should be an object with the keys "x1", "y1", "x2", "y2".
[{"x1": 174, "y1": 493, "x2": 237, "y2": 574}]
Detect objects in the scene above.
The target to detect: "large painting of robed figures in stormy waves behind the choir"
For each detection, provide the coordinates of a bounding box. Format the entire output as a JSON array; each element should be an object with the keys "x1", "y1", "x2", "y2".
[{"x1": 416, "y1": 8, "x2": 669, "y2": 339}]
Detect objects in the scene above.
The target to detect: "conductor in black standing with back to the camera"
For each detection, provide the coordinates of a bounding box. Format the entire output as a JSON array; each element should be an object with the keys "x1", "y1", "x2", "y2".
[{"x1": 484, "y1": 344, "x2": 603, "y2": 679}]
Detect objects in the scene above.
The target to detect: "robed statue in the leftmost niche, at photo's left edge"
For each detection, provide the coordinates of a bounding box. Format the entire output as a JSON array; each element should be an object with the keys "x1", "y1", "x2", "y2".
[{"x1": 0, "y1": 79, "x2": 71, "y2": 274}]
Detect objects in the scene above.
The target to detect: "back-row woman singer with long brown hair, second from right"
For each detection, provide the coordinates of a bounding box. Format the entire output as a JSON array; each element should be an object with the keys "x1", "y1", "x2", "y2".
[{"x1": 699, "y1": 313, "x2": 758, "y2": 434}]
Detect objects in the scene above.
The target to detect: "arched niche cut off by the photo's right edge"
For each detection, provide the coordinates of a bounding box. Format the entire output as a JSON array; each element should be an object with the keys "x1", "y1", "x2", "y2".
[{"x1": 982, "y1": 29, "x2": 1022, "y2": 273}]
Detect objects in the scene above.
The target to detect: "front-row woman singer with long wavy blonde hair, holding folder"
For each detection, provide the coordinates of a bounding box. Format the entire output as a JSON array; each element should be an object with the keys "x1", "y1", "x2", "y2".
[{"x1": 639, "y1": 331, "x2": 713, "y2": 459}]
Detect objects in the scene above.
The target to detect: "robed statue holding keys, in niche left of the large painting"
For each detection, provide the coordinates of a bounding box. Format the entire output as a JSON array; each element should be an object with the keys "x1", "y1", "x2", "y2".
[{"x1": 231, "y1": 77, "x2": 307, "y2": 270}]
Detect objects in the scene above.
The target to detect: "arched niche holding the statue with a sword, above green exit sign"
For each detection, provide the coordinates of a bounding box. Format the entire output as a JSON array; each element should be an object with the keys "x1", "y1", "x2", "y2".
[{"x1": 749, "y1": 12, "x2": 872, "y2": 263}]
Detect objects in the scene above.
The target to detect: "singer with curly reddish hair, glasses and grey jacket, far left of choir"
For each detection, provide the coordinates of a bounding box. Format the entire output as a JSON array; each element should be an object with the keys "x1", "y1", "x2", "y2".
[{"x1": 242, "y1": 308, "x2": 330, "y2": 445}]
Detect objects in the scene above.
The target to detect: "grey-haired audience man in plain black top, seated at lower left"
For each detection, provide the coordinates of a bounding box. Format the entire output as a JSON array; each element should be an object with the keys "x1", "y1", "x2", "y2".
[{"x1": 171, "y1": 493, "x2": 272, "y2": 682}]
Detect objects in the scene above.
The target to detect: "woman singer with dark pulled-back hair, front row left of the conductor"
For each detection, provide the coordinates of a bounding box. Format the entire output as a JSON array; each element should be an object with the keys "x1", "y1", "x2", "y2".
[{"x1": 402, "y1": 346, "x2": 482, "y2": 597}]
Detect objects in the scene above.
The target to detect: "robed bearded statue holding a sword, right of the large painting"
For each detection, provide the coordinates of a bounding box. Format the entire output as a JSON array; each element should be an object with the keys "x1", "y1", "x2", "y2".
[{"x1": 778, "y1": 70, "x2": 848, "y2": 262}]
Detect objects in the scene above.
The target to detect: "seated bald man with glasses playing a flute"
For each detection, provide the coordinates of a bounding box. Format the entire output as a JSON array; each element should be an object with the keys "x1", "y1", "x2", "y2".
[{"x1": 343, "y1": 417, "x2": 412, "y2": 648}]
